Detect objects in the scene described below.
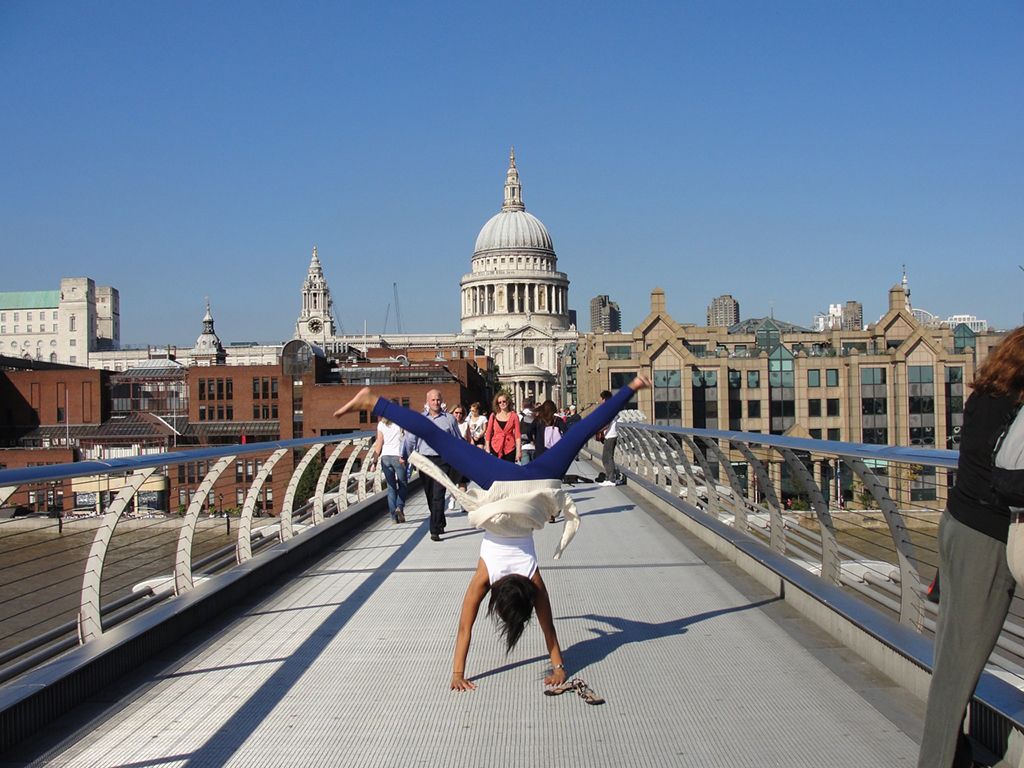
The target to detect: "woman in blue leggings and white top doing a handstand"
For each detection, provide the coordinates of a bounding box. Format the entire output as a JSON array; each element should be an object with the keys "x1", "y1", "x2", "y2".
[{"x1": 335, "y1": 377, "x2": 650, "y2": 691}]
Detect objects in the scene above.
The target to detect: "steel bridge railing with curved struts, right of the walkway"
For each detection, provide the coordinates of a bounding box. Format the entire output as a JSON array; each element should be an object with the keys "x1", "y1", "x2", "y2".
[{"x1": 616, "y1": 428, "x2": 1024, "y2": 687}]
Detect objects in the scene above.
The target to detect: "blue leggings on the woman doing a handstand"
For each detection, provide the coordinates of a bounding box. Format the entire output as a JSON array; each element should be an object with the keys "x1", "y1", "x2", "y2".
[{"x1": 374, "y1": 387, "x2": 634, "y2": 489}]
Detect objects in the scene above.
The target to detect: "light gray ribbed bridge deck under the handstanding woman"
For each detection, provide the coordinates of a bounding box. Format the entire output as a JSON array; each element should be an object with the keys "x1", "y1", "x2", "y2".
[{"x1": 4, "y1": 466, "x2": 923, "y2": 768}]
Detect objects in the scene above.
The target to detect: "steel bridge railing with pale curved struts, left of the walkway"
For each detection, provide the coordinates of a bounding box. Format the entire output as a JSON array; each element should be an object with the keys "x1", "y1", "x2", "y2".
[{"x1": 0, "y1": 432, "x2": 381, "y2": 683}]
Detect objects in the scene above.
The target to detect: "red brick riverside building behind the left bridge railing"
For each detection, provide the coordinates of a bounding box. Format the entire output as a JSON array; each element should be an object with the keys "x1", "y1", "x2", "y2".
[{"x1": 0, "y1": 340, "x2": 490, "y2": 513}]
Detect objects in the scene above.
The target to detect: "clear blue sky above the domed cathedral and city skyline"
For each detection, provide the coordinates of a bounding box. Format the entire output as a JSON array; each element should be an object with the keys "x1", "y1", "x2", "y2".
[{"x1": 0, "y1": 0, "x2": 1024, "y2": 344}]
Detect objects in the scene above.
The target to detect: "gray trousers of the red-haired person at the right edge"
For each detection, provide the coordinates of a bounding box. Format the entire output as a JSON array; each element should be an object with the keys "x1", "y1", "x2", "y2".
[{"x1": 918, "y1": 512, "x2": 1016, "y2": 768}]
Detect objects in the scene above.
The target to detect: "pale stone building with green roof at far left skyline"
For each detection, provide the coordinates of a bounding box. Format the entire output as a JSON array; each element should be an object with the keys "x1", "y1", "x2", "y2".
[{"x1": 0, "y1": 278, "x2": 121, "y2": 366}]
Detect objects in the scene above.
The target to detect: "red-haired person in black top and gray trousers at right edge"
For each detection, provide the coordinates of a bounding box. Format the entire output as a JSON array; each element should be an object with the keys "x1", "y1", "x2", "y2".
[{"x1": 918, "y1": 328, "x2": 1024, "y2": 768}]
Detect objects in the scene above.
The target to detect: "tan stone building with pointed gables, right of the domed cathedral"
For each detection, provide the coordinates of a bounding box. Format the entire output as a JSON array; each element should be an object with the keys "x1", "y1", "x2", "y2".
[{"x1": 578, "y1": 285, "x2": 1000, "y2": 449}]
